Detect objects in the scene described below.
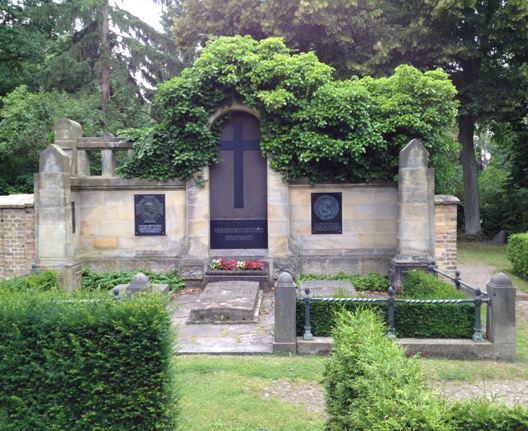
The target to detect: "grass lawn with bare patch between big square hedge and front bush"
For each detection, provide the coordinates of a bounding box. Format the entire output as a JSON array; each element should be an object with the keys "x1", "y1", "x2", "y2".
[{"x1": 177, "y1": 355, "x2": 325, "y2": 431}]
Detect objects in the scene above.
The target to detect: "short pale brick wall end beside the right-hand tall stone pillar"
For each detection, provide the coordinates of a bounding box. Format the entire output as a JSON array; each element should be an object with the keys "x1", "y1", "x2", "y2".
[{"x1": 434, "y1": 195, "x2": 460, "y2": 274}]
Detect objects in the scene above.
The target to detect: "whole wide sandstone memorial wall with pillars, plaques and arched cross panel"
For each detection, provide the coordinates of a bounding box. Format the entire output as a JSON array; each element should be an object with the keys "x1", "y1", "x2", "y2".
[{"x1": 0, "y1": 103, "x2": 458, "y2": 287}]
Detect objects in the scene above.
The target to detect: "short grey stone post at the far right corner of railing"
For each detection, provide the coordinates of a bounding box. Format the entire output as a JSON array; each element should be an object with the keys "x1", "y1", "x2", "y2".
[{"x1": 486, "y1": 272, "x2": 517, "y2": 360}]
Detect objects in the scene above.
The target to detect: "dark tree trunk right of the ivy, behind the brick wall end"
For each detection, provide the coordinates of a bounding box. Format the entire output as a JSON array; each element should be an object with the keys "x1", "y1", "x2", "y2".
[{"x1": 458, "y1": 115, "x2": 481, "y2": 235}]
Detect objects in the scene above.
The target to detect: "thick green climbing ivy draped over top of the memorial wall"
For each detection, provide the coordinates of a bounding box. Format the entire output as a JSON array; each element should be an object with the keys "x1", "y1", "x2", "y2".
[{"x1": 121, "y1": 36, "x2": 457, "y2": 182}]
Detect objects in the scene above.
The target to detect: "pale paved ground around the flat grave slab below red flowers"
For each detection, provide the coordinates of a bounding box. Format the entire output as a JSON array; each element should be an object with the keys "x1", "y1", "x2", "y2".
[{"x1": 171, "y1": 289, "x2": 275, "y2": 354}]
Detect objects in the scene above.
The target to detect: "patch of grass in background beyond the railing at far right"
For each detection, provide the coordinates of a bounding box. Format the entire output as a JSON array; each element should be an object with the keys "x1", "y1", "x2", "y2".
[{"x1": 458, "y1": 242, "x2": 528, "y2": 293}]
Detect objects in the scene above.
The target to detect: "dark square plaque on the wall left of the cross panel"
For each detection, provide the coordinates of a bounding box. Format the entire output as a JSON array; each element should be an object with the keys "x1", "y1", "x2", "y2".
[{"x1": 134, "y1": 195, "x2": 165, "y2": 236}]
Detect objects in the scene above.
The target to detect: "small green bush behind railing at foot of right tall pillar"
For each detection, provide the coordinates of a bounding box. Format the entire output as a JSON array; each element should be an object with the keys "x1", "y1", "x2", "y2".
[{"x1": 403, "y1": 271, "x2": 467, "y2": 299}]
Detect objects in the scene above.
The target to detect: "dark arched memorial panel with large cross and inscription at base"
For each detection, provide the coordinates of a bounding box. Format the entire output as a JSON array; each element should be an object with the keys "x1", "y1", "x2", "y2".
[{"x1": 210, "y1": 112, "x2": 268, "y2": 249}]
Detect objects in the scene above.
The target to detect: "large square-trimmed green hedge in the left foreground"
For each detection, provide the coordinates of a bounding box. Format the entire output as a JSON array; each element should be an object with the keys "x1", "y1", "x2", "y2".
[{"x1": 0, "y1": 291, "x2": 177, "y2": 431}]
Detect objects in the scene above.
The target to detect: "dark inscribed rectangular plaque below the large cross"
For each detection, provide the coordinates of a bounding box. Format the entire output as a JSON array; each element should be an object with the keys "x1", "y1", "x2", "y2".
[{"x1": 211, "y1": 220, "x2": 268, "y2": 248}]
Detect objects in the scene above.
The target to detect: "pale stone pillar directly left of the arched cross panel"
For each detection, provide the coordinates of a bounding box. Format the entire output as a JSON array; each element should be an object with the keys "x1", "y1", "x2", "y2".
[{"x1": 180, "y1": 167, "x2": 210, "y2": 284}]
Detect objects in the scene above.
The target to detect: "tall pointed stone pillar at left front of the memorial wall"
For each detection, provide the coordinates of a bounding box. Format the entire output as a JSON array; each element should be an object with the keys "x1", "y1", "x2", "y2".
[{"x1": 35, "y1": 144, "x2": 80, "y2": 289}]
